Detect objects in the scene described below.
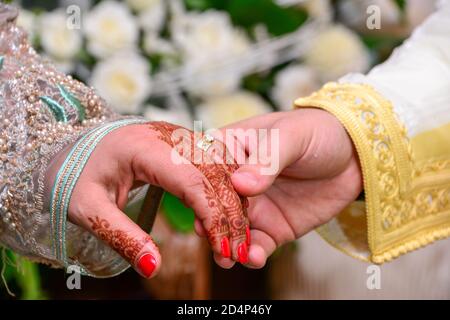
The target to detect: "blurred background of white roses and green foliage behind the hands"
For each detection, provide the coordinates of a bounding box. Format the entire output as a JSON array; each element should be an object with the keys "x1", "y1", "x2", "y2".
[{"x1": 0, "y1": 0, "x2": 434, "y2": 299}]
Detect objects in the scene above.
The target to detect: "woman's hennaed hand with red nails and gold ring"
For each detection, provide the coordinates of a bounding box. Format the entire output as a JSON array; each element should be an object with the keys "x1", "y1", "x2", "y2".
[{"x1": 47, "y1": 122, "x2": 248, "y2": 278}]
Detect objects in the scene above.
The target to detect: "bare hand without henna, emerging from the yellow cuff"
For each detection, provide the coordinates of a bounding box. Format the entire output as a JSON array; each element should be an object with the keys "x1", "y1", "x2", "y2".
[{"x1": 204, "y1": 109, "x2": 362, "y2": 268}]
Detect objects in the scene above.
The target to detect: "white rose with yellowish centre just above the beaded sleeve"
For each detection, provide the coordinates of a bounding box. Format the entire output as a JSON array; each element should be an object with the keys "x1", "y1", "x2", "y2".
[{"x1": 90, "y1": 52, "x2": 151, "y2": 114}]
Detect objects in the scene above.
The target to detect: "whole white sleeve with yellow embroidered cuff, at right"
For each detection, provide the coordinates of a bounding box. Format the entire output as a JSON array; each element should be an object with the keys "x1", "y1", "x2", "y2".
[{"x1": 296, "y1": 2, "x2": 450, "y2": 263}]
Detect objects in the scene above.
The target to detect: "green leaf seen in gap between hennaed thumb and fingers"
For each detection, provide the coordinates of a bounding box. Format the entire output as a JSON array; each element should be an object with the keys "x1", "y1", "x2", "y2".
[{"x1": 161, "y1": 192, "x2": 195, "y2": 232}]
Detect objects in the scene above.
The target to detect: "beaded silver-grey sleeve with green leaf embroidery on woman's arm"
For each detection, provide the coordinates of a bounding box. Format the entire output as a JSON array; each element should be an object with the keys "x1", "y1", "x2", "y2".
[{"x1": 0, "y1": 4, "x2": 134, "y2": 276}]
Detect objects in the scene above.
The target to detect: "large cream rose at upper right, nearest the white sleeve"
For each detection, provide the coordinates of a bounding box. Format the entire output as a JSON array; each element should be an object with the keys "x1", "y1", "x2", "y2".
[{"x1": 305, "y1": 25, "x2": 370, "y2": 81}]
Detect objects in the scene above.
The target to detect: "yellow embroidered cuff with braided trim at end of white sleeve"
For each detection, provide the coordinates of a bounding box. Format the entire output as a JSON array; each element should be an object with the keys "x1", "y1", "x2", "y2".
[{"x1": 295, "y1": 83, "x2": 450, "y2": 263}]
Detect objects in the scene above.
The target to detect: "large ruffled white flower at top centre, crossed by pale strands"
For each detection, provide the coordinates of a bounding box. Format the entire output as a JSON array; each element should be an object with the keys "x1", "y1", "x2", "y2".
[{"x1": 172, "y1": 10, "x2": 250, "y2": 96}]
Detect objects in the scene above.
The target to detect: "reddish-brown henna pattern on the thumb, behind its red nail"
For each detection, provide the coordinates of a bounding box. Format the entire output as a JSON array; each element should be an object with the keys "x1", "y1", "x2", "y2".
[{"x1": 88, "y1": 216, "x2": 151, "y2": 264}]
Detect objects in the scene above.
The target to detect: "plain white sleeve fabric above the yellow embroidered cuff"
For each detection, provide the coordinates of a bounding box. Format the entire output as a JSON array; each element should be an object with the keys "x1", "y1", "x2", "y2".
[{"x1": 339, "y1": 1, "x2": 450, "y2": 137}]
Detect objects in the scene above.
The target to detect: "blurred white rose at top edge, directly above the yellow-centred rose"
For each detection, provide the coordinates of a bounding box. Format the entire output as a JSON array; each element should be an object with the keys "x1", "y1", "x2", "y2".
[{"x1": 84, "y1": 0, "x2": 139, "y2": 58}]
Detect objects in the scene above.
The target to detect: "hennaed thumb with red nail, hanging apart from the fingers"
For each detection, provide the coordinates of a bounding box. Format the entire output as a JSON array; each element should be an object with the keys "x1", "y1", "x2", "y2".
[{"x1": 69, "y1": 194, "x2": 161, "y2": 278}]
